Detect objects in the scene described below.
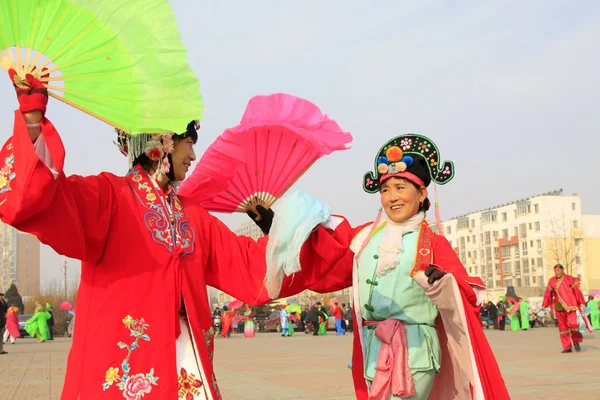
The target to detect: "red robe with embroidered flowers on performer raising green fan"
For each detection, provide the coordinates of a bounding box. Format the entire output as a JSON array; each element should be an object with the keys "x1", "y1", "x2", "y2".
[{"x1": 0, "y1": 111, "x2": 269, "y2": 400}]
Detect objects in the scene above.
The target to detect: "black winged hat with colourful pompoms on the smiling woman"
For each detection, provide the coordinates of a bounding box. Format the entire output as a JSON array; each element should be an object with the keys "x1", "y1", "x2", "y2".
[{"x1": 363, "y1": 133, "x2": 454, "y2": 194}]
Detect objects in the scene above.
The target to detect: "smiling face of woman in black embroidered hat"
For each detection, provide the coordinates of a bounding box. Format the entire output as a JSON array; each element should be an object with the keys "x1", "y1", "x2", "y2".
[{"x1": 381, "y1": 177, "x2": 427, "y2": 223}]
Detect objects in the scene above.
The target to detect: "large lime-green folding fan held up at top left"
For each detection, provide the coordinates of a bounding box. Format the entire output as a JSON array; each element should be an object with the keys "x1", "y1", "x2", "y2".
[{"x1": 0, "y1": 0, "x2": 203, "y2": 134}]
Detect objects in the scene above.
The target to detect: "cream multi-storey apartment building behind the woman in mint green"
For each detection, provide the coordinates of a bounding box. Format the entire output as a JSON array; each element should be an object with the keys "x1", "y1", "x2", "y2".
[{"x1": 443, "y1": 189, "x2": 600, "y2": 300}]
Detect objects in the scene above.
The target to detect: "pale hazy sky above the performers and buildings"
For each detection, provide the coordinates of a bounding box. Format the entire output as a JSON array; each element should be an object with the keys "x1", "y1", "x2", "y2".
[{"x1": 0, "y1": 0, "x2": 600, "y2": 281}]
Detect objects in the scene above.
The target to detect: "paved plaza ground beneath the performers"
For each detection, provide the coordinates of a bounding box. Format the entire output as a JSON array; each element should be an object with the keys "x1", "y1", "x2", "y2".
[{"x1": 0, "y1": 328, "x2": 600, "y2": 400}]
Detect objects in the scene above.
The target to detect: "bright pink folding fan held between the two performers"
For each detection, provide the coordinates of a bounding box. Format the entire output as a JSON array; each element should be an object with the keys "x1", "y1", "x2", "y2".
[{"x1": 180, "y1": 93, "x2": 352, "y2": 215}]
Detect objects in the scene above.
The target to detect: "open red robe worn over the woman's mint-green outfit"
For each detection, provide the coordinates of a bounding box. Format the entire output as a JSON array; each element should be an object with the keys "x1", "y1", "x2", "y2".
[{"x1": 279, "y1": 217, "x2": 510, "y2": 400}]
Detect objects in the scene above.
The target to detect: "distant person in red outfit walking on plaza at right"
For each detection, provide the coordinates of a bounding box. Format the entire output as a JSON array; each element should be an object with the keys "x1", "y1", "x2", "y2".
[{"x1": 542, "y1": 264, "x2": 585, "y2": 353}]
